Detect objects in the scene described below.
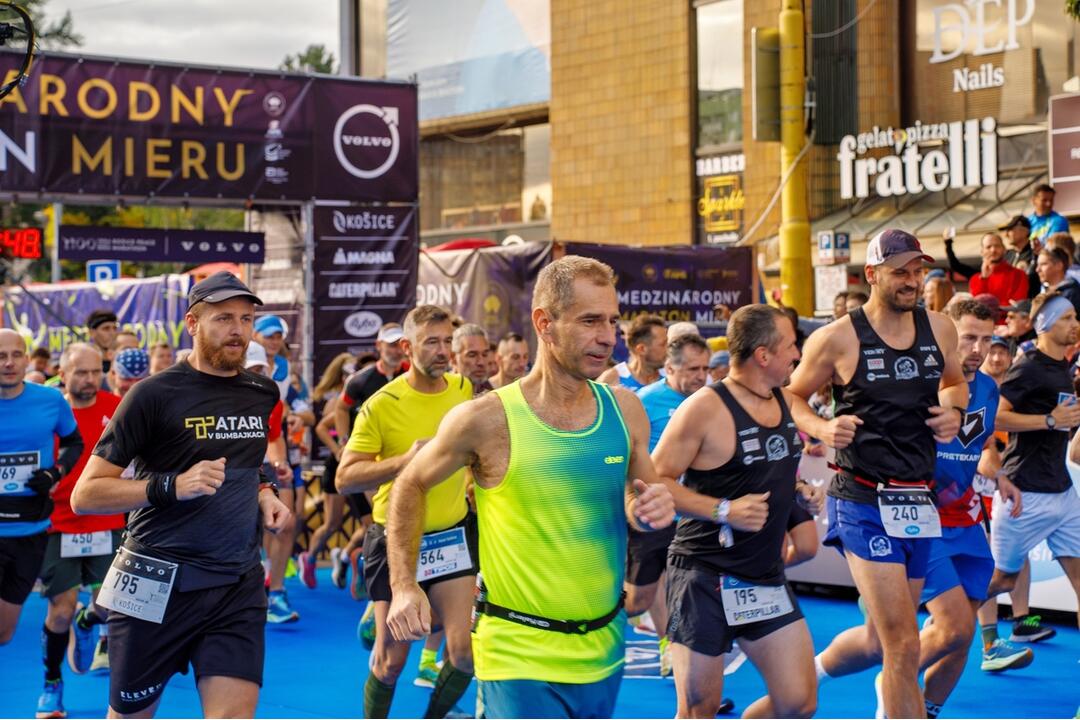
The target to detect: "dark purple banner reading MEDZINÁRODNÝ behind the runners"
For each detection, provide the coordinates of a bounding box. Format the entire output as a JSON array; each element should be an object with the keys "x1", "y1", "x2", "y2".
[{"x1": 566, "y1": 243, "x2": 755, "y2": 323}]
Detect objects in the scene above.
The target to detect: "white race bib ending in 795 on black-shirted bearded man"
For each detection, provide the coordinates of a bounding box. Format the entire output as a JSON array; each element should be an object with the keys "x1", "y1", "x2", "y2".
[{"x1": 94, "y1": 546, "x2": 179, "y2": 624}]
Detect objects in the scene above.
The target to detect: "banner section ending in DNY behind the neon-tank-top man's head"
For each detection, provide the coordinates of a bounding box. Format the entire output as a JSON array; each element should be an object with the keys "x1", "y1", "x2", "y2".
[{"x1": 416, "y1": 243, "x2": 552, "y2": 352}]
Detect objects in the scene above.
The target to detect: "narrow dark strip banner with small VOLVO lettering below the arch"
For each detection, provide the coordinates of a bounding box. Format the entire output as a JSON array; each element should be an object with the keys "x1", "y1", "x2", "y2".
[{"x1": 59, "y1": 225, "x2": 266, "y2": 263}]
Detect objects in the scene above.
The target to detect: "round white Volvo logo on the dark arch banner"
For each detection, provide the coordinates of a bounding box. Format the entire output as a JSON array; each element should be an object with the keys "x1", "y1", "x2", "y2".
[{"x1": 334, "y1": 105, "x2": 401, "y2": 180}]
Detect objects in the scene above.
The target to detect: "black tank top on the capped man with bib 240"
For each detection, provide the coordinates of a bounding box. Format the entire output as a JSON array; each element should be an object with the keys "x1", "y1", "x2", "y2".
[{"x1": 828, "y1": 308, "x2": 945, "y2": 503}]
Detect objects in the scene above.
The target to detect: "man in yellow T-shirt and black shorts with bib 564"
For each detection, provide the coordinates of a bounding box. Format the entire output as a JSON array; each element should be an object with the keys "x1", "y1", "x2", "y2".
[{"x1": 336, "y1": 305, "x2": 476, "y2": 718}]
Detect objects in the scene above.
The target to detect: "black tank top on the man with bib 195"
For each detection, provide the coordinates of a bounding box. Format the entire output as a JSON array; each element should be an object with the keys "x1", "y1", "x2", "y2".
[{"x1": 670, "y1": 381, "x2": 802, "y2": 585}]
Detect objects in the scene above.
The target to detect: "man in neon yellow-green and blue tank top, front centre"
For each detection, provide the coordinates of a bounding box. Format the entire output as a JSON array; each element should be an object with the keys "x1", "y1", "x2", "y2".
[{"x1": 388, "y1": 256, "x2": 674, "y2": 718}]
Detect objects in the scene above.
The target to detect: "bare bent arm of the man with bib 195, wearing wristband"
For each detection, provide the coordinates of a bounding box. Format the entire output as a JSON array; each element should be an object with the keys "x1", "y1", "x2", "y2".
[{"x1": 652, "y1": 390, "x2": 734, "y2": 520}]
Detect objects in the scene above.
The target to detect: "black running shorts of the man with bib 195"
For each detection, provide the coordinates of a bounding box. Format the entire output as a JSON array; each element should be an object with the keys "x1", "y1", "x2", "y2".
[{"x1": 667, "y1": 565, "x2": 802, "y2": 657}]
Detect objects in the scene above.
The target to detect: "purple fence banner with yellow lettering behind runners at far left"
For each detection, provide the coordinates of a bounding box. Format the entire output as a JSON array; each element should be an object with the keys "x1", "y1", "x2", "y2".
[{"x1": 2, "y1": 275, "x2": 191, "y2": 356}]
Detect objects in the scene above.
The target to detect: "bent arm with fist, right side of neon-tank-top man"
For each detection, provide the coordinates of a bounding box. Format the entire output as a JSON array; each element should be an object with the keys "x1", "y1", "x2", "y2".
[{"x1": 613, "y1": 388, "x2": 675, "y2": 532}]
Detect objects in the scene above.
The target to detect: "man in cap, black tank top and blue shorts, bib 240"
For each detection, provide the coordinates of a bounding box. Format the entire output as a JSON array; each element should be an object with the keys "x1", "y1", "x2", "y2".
[{"x1": 789, "y1": 229, "x2": 968, "y2": 718}]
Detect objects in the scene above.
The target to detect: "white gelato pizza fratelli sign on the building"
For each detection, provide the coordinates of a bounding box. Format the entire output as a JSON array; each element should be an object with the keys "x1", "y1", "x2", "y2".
[{"x1": 836, "y1": 118, "x2": 998, "y2": 200}]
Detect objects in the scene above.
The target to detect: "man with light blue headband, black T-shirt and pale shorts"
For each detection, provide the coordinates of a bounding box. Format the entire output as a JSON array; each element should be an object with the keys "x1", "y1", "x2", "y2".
[{"x1": 989, "y1": 294, "x2": 1080, "y2": 623}]
